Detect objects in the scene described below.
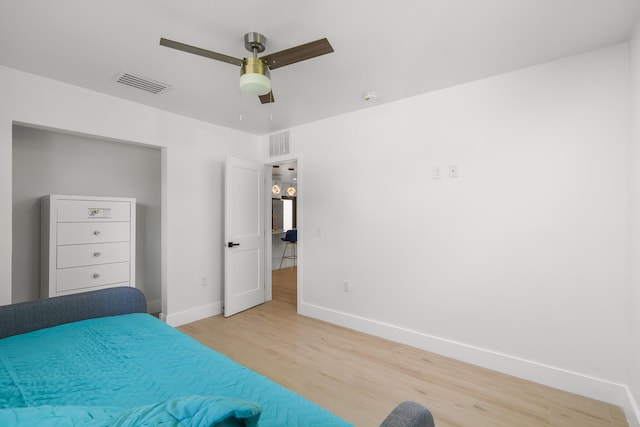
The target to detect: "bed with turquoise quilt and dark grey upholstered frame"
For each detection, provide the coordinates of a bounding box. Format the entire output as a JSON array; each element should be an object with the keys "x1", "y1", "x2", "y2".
[{"x1": 0, "y1": 287, "x2": 433, "y2": 427}]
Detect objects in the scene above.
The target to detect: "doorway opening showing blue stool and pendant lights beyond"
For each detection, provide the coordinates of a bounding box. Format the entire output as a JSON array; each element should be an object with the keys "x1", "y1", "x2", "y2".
[{"x1": 270, "y1": 160, "x2": 298, "y2": 311}]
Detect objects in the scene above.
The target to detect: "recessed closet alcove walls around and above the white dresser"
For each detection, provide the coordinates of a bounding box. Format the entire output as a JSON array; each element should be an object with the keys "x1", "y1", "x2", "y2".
[{"x1": 11, "y1": 125, "x2": 161, "y2": 311}]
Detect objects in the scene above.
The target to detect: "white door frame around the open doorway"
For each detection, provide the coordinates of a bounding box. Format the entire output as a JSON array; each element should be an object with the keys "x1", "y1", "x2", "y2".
[{"x1": 264, "y1": 153, "x2": 304, "y2": 313}]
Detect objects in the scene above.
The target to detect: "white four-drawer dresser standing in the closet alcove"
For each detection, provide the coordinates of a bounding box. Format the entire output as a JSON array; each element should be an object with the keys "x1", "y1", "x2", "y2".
[{"x1": 40, "y1": 194, "x2": 136, "y2": 298}]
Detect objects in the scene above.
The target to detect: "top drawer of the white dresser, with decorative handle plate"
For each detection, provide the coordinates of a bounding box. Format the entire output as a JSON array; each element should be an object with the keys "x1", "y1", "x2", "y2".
[{"x1": 58, "y1": 200, "x2": 131, "y2": 222}]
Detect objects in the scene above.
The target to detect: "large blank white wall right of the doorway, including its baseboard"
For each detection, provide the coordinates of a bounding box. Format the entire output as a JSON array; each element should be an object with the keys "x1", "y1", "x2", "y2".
[{"x1": 291, "y1": 44, "x2": 630, "y2": 412}]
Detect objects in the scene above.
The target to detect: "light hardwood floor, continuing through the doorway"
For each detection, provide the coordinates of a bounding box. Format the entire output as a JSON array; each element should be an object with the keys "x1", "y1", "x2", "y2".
[{"x1": 179, "y1": 268, "x2": 628, "y2": 427}]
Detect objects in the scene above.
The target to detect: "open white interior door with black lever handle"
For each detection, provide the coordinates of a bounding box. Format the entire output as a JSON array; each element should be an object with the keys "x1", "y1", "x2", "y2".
[{"x1": 224, "y1": 157, "x2": 265, "y2": 317}]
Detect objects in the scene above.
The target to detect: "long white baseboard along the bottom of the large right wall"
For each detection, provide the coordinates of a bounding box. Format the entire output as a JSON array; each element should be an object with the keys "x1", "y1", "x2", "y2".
[{"x1": 299, "y1": 302, "x2": 640, "y2": 427}]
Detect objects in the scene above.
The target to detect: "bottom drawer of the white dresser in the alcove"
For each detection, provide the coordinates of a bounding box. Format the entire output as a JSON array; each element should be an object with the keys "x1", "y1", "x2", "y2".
[{"x1": 56, "y1": 262, "x2": 129, "y2": 292}]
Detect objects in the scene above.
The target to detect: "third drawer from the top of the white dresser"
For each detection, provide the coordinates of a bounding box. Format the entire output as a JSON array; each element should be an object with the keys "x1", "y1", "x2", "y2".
[{"x1": 56, "y1": 242, "x2": 130, "y2": 268}]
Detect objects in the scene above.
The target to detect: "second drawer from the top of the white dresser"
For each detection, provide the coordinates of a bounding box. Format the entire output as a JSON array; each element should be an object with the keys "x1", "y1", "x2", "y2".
[{"x1": 57, "y1": 222, "x2": 131, "y2": 245}]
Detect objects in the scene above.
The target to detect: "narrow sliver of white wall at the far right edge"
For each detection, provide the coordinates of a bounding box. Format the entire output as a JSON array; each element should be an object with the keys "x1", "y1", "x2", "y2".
[{"x1": 629, "y1": 23, "x2": 640, "y2": 426}]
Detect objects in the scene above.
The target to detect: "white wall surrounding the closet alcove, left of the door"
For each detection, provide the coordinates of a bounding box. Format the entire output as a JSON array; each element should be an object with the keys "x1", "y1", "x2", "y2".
[{"x1": 0, "y1": 67, "x2": 260, "y2": 324}]
